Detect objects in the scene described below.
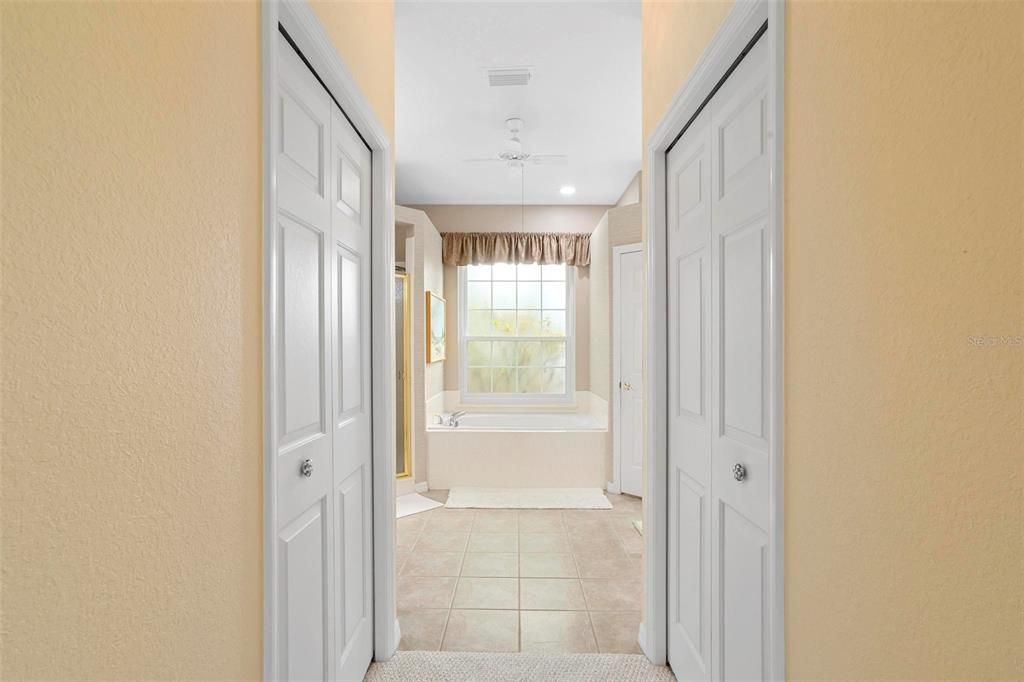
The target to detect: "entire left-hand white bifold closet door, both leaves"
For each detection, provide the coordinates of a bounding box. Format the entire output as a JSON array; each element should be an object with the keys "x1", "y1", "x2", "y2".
[{"x1": 272, "y1": 36, "x2": 373, "y2": 680}]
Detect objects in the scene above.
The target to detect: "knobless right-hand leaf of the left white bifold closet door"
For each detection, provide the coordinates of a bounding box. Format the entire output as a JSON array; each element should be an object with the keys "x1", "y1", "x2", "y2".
[{"x1": 329, "y1": 105, "x2": 373, "y2": 680}]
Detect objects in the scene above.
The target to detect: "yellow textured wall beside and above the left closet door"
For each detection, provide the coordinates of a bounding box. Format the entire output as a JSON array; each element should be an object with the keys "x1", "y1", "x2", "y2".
[{"x1": 0, "y1": 2, "x2": 393, "y2": 680}]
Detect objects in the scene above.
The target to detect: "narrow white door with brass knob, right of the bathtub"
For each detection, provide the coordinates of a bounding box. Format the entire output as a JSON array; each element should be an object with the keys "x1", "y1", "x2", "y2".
[{"x1": 611, "y1": 245, "x2": 643, "y2": 497}]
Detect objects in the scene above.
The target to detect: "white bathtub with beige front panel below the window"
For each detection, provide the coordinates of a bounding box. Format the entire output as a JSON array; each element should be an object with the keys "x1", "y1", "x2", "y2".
[{"x1": 426, "y1": 405, "x2": 611, "y2": 488}]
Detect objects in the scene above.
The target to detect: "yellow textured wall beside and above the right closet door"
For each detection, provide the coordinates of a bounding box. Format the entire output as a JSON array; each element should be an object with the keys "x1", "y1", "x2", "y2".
[{"x1": 643, "y1": 2, "x2": 1024, "y2": 680}]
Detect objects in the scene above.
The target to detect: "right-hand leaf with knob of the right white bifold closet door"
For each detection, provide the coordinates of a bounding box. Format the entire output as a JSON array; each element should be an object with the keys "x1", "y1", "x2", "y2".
[{"x1": 712, "y1": 38, "x2": 772, "y2": 680}]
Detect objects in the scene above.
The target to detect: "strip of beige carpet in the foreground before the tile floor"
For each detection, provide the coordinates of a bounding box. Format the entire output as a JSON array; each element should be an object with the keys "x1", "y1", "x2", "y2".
[{"x1": 365, "y1": 651, "x2": 676, "y2": 682}]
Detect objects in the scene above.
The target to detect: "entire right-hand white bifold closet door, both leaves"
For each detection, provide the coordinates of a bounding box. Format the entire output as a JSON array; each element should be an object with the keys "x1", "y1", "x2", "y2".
[{"x1": 667, "y1": 33, "x2": 772, "y2": 680}]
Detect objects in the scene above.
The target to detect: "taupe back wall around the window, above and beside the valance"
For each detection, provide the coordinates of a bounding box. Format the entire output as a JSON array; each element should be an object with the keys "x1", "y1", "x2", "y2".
[{"x1": 419, "y1": 204, "x2": 608, "y2": 391}]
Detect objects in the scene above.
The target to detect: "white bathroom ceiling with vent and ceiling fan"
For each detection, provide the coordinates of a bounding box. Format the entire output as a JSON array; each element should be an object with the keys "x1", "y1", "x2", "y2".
[{"x1": 395, "y1": 0, "x2": 641, "y2": 204}]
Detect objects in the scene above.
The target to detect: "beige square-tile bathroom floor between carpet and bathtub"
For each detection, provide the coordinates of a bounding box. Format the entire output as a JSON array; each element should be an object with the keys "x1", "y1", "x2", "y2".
[{"x1": 397, "y1": 491, "x2": 643, "y2": 653}]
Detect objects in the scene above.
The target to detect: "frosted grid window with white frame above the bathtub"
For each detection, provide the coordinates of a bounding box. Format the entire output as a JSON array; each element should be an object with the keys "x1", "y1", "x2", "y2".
[{"x1": 459, "y1": 263, "x2": 573, "y2": 401}]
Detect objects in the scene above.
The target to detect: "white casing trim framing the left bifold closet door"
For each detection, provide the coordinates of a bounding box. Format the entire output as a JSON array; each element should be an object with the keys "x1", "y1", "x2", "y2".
[{"x1": 260, "y1": 0, "x2": 400, "y2": 680}]
